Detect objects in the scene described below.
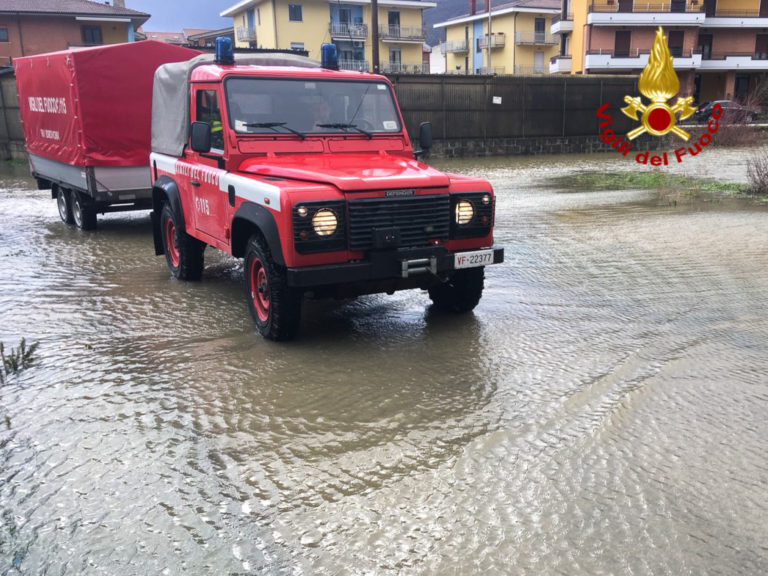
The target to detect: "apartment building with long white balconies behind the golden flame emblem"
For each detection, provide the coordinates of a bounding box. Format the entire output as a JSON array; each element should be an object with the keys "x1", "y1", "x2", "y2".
[{"x1": 550, "y1": 0, "x2": 768, "y2": 102}]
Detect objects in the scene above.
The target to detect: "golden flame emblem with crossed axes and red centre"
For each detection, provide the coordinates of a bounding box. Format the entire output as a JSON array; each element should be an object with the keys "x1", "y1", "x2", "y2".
[{"x1": 621, "y1": 26, "x2": 696, "y2": 141}]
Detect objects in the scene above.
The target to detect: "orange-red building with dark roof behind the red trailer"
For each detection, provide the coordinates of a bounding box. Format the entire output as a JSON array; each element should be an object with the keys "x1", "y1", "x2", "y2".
[{"x1": 0, "y1": 0, "x2": 149, "y2": 65}]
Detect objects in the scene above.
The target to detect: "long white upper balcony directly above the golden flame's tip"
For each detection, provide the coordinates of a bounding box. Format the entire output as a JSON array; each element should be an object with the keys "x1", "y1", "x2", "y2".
[{"x1": 587, "y1": 0, "x2": 709, "y2": 26}]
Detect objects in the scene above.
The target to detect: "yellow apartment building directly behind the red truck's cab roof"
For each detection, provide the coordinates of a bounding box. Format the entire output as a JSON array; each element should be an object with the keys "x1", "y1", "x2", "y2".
[{"x1": 221, "y1": 0, "x2": 436, "y2": 73}]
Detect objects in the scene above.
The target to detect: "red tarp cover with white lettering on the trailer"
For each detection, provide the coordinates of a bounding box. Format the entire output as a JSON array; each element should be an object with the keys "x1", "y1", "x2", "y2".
[{"x1": 14, "y1": 40, "x2": 200, "y2": 166}]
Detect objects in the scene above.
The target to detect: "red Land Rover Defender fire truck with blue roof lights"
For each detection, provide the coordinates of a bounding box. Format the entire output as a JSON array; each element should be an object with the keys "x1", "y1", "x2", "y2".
[{"x1": 150, "y1": 42, "x2": 504, "y2": 340}]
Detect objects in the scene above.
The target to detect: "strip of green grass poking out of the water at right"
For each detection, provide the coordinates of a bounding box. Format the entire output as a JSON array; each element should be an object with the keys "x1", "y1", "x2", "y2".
[{"x1": 548, "y1": 172, "x2": 750, "y2": 195}]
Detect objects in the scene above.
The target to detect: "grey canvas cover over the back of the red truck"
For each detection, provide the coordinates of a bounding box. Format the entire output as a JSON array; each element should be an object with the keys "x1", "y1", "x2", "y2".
[{"x1": 152, "y1": 54, "x2": 320, "y2": 156}]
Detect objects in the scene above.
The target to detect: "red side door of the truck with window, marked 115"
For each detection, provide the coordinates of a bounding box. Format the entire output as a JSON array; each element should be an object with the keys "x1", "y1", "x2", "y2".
[{"x1": 188, "y1": 86, "x2": 228, "y2": 243}]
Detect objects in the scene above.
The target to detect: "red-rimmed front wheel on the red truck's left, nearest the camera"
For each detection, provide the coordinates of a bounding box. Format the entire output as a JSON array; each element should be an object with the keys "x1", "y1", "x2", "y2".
[{"x1": 243, "y1": 235, "x2": 302, "y2": 340}]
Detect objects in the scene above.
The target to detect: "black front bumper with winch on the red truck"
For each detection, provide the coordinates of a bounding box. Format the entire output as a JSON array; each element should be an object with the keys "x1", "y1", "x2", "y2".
[{"x1": 286, "y1": 247, "x2": 504, "y2": 288}]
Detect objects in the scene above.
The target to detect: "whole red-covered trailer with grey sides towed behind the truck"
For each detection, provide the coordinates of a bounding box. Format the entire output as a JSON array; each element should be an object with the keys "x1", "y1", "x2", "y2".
[{"x1": 14, "y1": 41, "x2": 199, "y2": 229}]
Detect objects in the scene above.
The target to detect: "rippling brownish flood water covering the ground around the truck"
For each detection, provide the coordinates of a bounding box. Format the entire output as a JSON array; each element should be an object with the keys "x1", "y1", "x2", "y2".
[{"x1": 0, "y1": 150, "x2": 768, "y2": 575}]
